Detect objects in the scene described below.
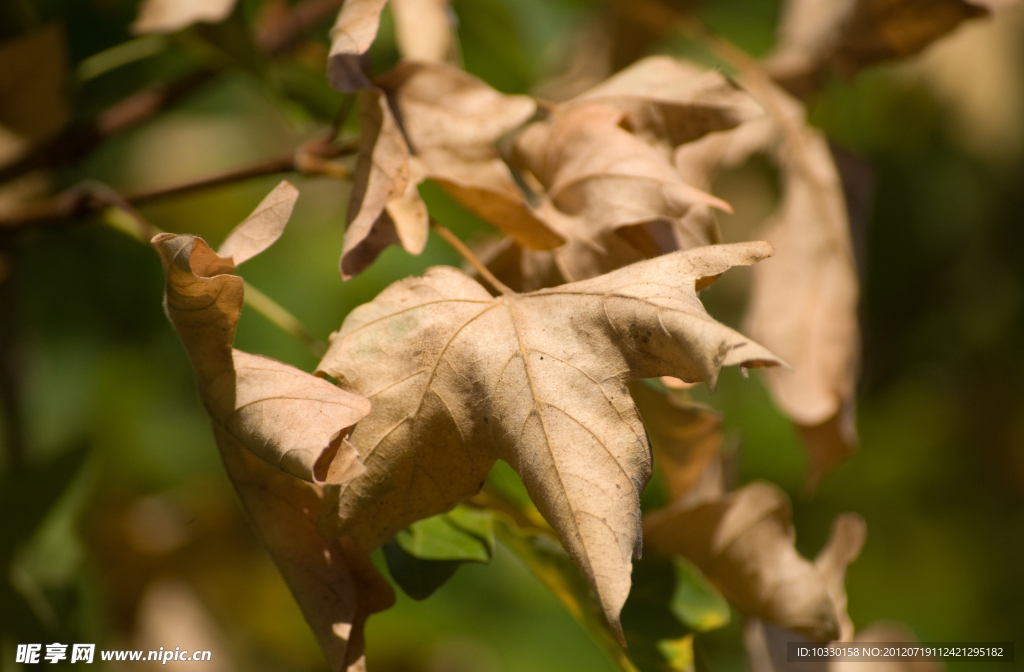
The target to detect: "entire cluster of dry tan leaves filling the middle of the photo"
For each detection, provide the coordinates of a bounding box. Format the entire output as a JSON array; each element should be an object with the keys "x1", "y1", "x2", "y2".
[{"x1": 135, "y1": 0, "x2": 1015, "y2": 670}]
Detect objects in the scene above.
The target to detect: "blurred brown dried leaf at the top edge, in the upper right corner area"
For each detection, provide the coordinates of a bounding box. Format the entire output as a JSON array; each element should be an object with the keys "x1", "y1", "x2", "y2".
[{"x1": 766, "y1": 0, "x2": 1001, "y2": 95}]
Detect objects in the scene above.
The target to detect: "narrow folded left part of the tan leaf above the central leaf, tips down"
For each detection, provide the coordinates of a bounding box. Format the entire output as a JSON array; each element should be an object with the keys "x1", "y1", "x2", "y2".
[{"x1": 341, "y1": 89, "x2": 430, "y2": 280}]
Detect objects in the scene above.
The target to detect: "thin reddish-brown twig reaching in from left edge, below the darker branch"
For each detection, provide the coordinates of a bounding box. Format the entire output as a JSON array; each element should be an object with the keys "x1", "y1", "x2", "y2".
[{"x1": 0, "y1": 140, "x2": 358, "y2": 234}]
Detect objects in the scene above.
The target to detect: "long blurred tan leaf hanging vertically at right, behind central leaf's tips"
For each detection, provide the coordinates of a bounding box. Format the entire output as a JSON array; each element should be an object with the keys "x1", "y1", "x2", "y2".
[{"x1": 676, "y1": 81, "x2": 860, "y2": 487}]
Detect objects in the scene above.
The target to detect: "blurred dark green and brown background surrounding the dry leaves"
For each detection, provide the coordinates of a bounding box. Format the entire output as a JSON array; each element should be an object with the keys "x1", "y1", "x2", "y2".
[{"x1": 0, "y1": 0, "x2": 1024, "y2": 672}]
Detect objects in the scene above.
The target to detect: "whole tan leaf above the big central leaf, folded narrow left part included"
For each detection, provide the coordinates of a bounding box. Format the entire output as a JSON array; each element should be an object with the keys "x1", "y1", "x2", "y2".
[{"x1": 341, "y1": 61, "x2": 564, "y2": 279}]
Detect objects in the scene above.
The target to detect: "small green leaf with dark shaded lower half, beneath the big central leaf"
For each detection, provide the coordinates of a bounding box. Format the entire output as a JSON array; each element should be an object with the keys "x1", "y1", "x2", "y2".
[{"x1": 384, "y1": 506, "x2": 495, "y2": 599}]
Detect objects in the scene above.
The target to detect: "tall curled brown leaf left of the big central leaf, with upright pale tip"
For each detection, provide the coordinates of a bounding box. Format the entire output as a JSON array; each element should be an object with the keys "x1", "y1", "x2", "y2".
[{"x1": 153, "y1": 182, "x2": 393, "y2": 670}]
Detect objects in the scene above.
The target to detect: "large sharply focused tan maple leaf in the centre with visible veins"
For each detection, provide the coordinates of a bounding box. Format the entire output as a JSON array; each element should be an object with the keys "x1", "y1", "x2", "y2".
[{"x1": 319, "y1": 243, "x2": 778, "y2": 630}]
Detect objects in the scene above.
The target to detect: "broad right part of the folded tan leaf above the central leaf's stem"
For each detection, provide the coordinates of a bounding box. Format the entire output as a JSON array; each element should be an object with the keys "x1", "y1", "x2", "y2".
[{"x1": 375, "y1": 61, "x2": 564, "y2": 250}]
